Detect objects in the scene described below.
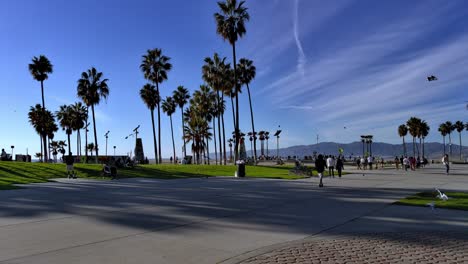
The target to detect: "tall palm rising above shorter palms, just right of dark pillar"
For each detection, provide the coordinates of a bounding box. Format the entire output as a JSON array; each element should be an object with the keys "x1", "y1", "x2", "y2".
[{"x1": 140, "y1": 49, "x2": 172, "y2": 163}]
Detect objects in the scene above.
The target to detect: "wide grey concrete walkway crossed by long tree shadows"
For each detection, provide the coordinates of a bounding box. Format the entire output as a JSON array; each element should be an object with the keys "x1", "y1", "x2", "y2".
[{"x1": 0, "y1": 166, "x2": 468, "y2": 264}]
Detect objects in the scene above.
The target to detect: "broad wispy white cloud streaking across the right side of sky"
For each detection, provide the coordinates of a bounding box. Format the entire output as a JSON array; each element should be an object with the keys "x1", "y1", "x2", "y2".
[{"x1": 252, "y1": 1, "x2": 468, "y2": 144}]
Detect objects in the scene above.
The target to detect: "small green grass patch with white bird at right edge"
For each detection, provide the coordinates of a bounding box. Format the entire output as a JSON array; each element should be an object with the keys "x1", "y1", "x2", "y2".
[{"x1": 395, "y1": 191, "x2": 468, "y2": 211}]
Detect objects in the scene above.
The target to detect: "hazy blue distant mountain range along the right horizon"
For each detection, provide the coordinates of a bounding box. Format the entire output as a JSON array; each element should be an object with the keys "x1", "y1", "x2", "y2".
[{"x1": 247, "y1": 142, "x2": 468, "y2": 159}]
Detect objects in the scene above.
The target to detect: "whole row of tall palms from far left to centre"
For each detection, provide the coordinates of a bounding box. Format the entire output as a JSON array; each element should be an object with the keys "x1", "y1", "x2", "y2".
[{"x1": 29, "y1": 0, "x2": 257, "y2": 164}]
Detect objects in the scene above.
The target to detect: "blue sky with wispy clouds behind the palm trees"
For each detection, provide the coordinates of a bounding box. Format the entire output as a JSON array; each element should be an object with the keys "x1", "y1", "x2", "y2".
[{"x1": 0, "y1": 0, "x2": 468, "y2": 157}]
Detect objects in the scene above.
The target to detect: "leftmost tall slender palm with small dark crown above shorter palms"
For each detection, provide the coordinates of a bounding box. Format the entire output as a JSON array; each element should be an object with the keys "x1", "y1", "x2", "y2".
[{"x1": 29, "y1": 55, "x2": 53, "y2": 162}]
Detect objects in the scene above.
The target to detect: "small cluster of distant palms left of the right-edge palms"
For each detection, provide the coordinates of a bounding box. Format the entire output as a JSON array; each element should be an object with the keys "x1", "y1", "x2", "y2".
[{"x1": 398, "y1": 117, "x2": 430, "y2": 157}]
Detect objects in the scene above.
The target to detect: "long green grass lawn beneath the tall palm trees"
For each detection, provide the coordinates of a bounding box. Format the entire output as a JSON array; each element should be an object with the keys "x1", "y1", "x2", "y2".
[{"x1": 0, "y1": 162, "x2": 330, "y2": 190}]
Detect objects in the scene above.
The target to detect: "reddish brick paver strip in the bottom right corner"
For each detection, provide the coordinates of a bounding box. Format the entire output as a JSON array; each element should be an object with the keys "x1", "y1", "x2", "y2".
[{"x1": 239, "y1": 232, "x2": 468, "y2": 264}]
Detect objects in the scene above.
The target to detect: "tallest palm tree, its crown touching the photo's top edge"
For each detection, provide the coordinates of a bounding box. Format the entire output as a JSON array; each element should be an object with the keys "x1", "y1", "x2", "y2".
[{"x1": 214, "y1": 0, "x2": 250, "y2": 160}]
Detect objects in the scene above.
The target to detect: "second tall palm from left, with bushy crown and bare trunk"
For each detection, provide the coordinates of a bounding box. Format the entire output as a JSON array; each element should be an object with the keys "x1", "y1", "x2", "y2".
[{"x1": 77, "y1": 67, "x2": 109, "y2": 163}]
